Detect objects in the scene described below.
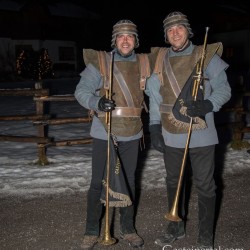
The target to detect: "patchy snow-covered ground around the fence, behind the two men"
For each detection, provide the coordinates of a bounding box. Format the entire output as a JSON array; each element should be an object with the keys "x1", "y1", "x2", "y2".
[{"x1": 0, "y1": 85, "x2": 250, "y2": 197}]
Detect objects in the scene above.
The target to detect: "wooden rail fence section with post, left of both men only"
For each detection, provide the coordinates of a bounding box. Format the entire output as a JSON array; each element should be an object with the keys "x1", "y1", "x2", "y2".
[{"x1": 0, "y1": 81, "x2": 92, "y2": 165}]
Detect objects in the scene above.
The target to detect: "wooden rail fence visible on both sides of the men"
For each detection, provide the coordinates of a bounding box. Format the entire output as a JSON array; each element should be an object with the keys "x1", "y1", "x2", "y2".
[{"x1": 0, "y1": 81, "x2": 250, "y2": 165}]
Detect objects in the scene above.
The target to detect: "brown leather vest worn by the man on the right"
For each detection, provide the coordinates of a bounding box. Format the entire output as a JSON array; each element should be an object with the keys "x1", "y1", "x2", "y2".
[{"x1": 151, "y1": 43, "x2": 222, "y2": 134}]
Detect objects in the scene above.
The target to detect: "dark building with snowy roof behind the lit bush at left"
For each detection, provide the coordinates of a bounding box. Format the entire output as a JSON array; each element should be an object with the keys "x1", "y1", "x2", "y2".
[{"x1": 0, "y1": 0, "x2": 99, "y2": 81}]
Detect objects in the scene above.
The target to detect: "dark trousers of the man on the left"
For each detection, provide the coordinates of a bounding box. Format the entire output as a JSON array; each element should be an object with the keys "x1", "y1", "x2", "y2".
[{"x1": 85, "y1": 139, "x2": 140, "y2": 235}]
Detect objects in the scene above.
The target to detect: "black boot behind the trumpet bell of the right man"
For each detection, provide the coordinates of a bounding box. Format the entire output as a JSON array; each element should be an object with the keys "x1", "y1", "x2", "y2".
[{"x1": 155, "y1": 186, "x2": 185, "y2": 247}]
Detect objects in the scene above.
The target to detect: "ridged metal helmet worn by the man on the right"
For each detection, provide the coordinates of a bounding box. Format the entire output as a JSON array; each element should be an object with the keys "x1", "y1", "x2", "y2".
[{"x1": 163, "y1": 11, "x2": 194, "y2": 42}]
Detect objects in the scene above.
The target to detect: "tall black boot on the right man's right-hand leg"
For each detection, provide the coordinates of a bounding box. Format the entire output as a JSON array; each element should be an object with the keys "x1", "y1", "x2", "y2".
[{"x1": 197, "y1": 195, "x2": 216, "y2": 250}]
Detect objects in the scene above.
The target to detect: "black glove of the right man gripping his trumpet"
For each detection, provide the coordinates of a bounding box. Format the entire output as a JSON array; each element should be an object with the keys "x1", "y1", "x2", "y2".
[{"x1": 186, "y1": 100, "x2": 213, "y2": 117}]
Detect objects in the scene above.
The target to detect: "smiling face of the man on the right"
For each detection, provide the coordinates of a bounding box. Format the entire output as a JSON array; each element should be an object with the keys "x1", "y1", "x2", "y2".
[{"x1": 166, "y1": 24, "x2": 189, "y2": 51}]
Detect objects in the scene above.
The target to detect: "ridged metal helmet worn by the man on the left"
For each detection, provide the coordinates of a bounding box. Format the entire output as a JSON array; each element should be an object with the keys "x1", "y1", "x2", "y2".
[{"x1": 111, "y1": 20, "x2": 139, "y2": 48}]
